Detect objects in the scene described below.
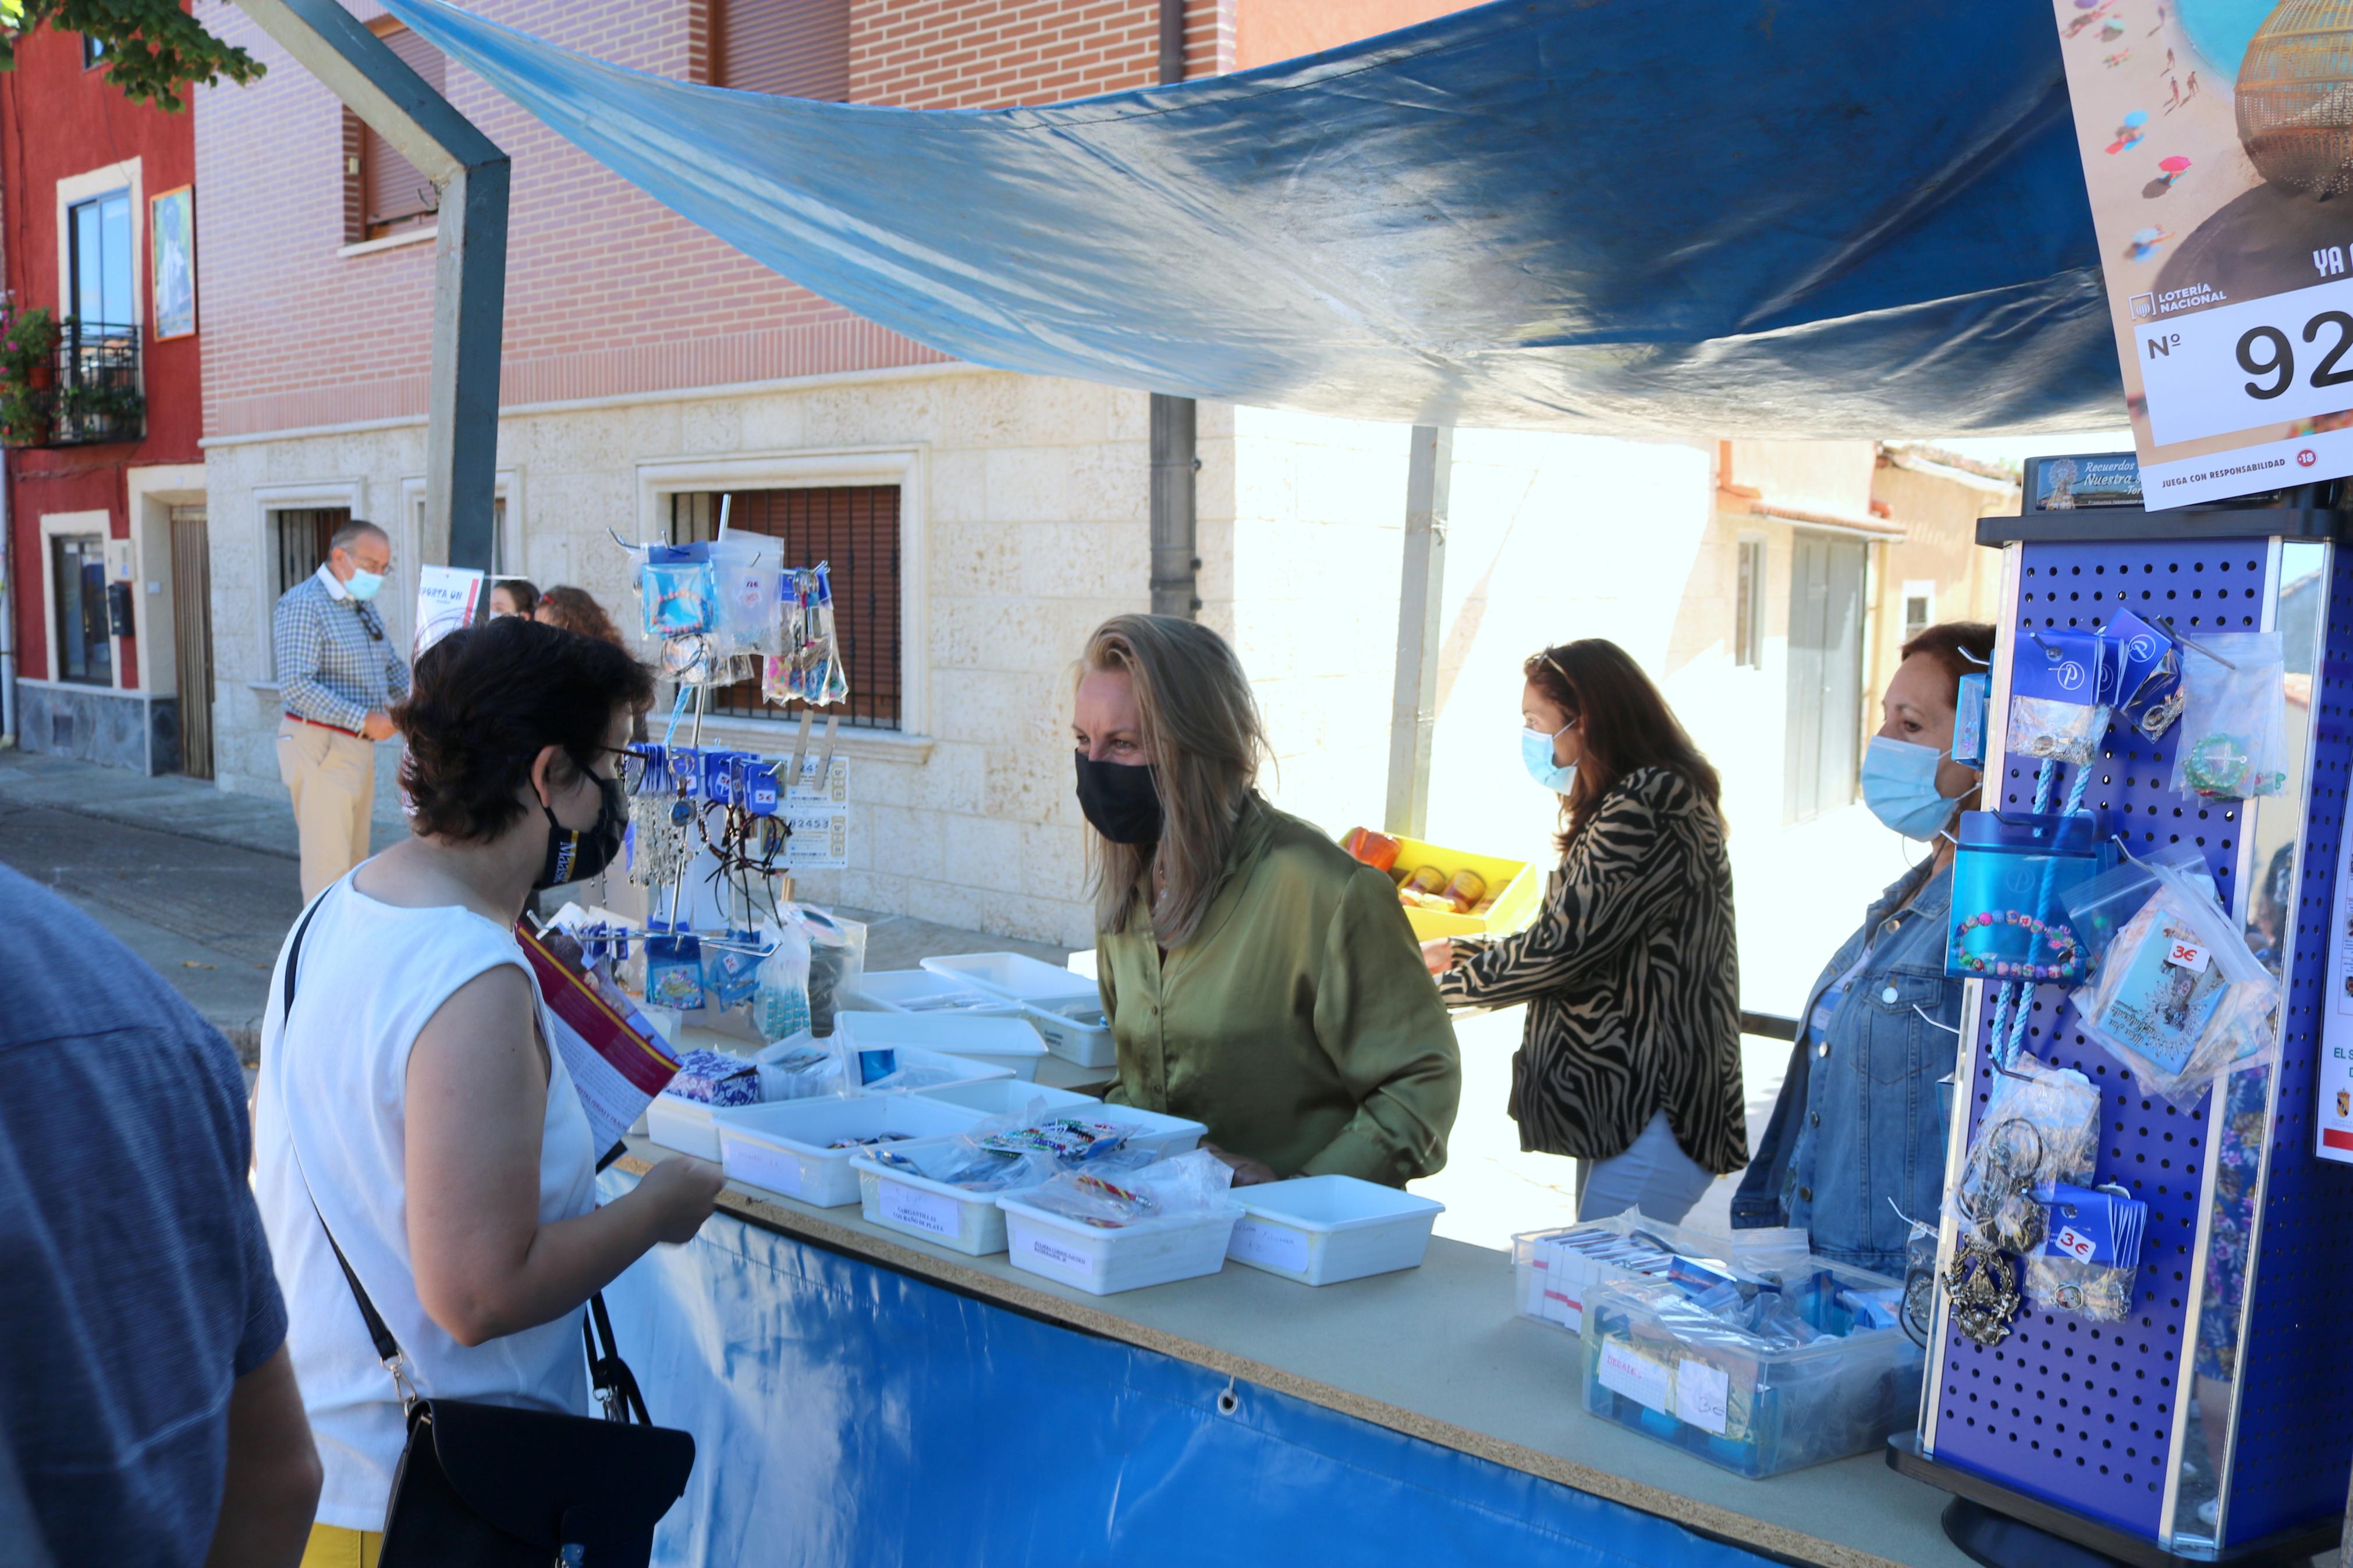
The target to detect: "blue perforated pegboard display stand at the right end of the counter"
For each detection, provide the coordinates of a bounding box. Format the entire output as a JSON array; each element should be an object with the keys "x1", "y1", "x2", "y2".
[{"x1": 1922, "y1": 538, "x2": 2353, "y2": 1549}]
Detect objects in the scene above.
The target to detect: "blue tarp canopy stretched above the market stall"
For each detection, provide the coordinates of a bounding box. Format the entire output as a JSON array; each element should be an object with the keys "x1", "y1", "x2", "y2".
[{"x1": 386, "y1": 0, "x2": 2125, "y2": 438}]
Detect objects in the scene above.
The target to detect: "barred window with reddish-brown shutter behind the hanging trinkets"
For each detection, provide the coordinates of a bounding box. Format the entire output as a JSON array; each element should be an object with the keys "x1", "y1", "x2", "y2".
[{"x1": 670, "y1": 484, "x2": 901, "y2": 729}]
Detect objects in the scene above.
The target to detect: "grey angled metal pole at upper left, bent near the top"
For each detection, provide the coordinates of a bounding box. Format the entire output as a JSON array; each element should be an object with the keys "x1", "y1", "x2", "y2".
[{"x1": 237, "y1": 0, "x2": 508, "y2": 585}]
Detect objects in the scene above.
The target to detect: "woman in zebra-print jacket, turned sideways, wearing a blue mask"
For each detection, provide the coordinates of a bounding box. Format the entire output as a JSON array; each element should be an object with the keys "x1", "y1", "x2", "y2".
[{"x1": 1424, "y1": 637, "x2": 1748, "y2": 1222}]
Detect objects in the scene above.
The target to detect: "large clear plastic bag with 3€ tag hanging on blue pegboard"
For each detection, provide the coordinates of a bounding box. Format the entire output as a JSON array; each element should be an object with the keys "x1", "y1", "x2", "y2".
[{"x1": 2068, "y1": 863, "x2": 2280, "y2": 1110}]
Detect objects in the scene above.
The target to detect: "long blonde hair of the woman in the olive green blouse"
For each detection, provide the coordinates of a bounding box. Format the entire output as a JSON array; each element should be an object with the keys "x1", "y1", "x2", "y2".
[{"x1": 1071, "y1": 616, "x2": 1266, "y2": 947}]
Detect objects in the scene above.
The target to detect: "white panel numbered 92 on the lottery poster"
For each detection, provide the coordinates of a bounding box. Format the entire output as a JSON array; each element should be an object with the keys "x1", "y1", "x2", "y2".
[{"x1": 2132, "y1": 278, "x2": 2353, "y2": 445}]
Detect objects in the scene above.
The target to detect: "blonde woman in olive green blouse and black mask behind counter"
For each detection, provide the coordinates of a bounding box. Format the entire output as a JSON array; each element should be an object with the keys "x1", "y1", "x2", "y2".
[{"x1": 1073, "y1": 616, "x2": 1461, "y2": 1187}]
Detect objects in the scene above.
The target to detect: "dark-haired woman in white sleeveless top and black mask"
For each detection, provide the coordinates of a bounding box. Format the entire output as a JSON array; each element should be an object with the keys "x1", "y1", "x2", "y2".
[{"x1": 254, "y1": 618, "x2": 720, "y2": 1563}]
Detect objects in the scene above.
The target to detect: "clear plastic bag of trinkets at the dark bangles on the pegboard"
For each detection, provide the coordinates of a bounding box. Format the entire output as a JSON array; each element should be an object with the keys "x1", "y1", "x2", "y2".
[{"x1": 1946, "y1": 1055, "x2": 2099, "y2": 1253}]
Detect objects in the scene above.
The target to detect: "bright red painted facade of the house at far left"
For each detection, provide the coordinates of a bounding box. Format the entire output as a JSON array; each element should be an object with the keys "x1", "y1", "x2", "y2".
[{"x1": 0, "y1": 17, "x2": 205, "y2": 687}]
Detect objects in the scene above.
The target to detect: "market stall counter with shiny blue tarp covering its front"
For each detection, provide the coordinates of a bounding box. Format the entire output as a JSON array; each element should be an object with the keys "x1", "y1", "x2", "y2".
[{"x1": 600, "y1": 1138, "x2": 1967, "y2": 1568}]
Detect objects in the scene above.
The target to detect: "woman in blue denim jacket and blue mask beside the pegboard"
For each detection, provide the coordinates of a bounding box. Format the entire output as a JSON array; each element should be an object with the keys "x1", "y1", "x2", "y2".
[{"x1": 1732, "y1": 621, "x2": 1993, "y2": 1279}]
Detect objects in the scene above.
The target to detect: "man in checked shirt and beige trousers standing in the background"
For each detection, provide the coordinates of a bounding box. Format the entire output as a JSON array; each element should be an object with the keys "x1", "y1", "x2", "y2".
[{"x1": 271, "y1": 517, "x2": 409, "y2": 901}]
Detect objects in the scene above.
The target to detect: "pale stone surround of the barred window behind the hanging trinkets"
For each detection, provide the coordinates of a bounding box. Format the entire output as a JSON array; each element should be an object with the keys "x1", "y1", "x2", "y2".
[{"x1": 640, "y1": 445, "x2": 932, "y2": 762}]
